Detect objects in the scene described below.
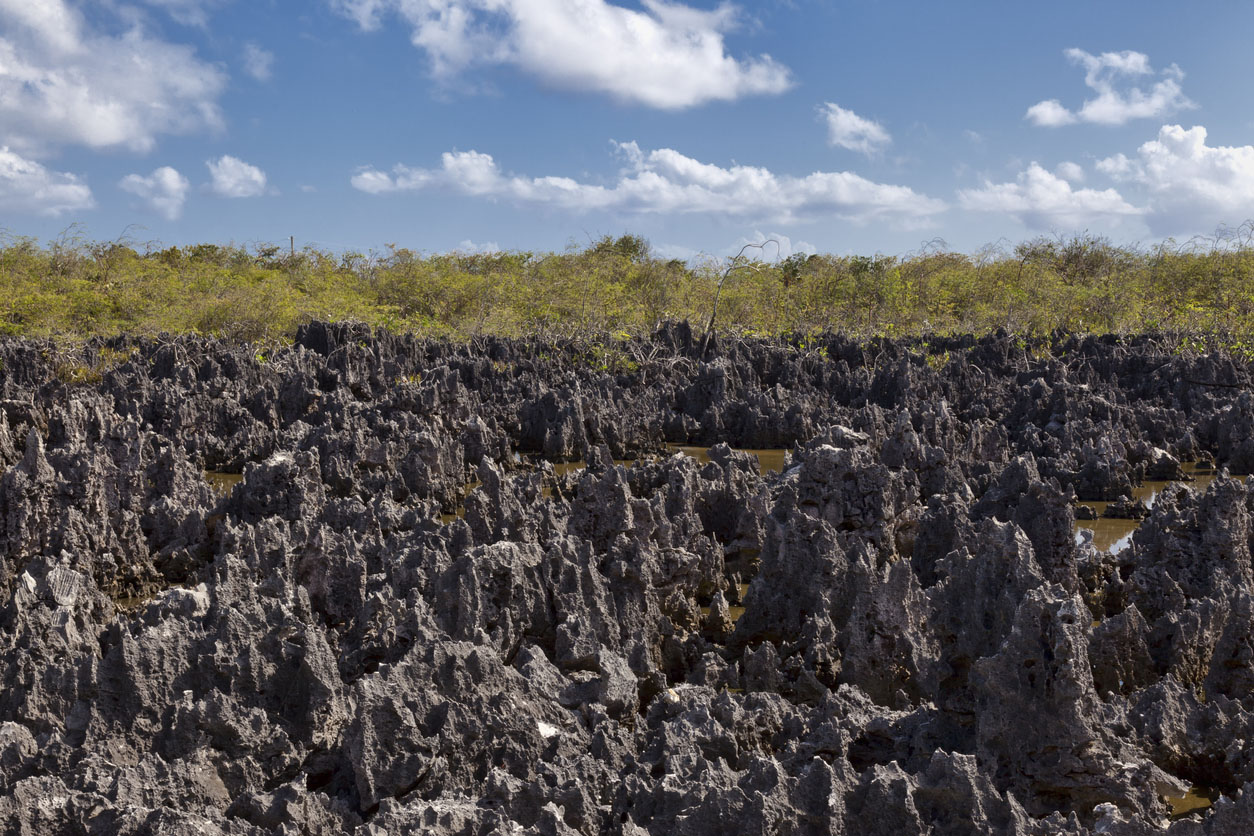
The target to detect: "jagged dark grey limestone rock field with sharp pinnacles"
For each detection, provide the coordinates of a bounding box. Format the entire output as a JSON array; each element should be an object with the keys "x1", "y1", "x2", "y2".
[{"x1": 0, "y1": 323, "x2": 1254, "y2": 836}]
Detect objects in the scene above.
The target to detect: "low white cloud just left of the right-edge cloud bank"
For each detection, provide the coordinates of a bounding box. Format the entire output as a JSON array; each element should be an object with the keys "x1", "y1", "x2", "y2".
[{"x1": 958, "y1": 163, "x2": 1144, "y2": 229}]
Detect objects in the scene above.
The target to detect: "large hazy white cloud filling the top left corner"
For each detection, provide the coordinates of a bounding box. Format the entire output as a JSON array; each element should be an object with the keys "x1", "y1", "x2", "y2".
[{"x1": 0, "y1": 0, "x2": 226, "y2": 155}]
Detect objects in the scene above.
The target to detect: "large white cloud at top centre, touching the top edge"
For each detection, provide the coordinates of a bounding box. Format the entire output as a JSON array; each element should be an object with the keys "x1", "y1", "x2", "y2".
[{"x1": 330, "y1": 0, "x2": 791, "y2": 110}]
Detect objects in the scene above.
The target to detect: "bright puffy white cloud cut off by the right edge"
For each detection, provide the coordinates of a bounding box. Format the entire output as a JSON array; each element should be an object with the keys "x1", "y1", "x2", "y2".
[{"x1": 1097, "y1": 125, "x2": 1254, "y2": 233}]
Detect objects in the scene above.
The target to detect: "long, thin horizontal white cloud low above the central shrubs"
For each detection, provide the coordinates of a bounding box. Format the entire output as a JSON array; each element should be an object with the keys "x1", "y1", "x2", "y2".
[{"x1": 351, "y1": 142, "x2": 946, "y2": 226}]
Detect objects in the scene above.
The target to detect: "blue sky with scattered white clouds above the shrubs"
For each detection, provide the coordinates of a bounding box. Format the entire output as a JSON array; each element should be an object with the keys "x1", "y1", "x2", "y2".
[{"x1": 0, "y1": 0, "x2": 1254, "y2": 258}]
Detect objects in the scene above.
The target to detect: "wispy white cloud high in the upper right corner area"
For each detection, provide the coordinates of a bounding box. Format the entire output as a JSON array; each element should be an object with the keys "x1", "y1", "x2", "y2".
[{"x1": 1025, "y1": 49, "x2": 1198, "y2": 128}]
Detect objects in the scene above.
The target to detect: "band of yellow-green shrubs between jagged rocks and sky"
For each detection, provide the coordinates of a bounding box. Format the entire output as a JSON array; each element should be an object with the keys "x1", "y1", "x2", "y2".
[{"x1": 0, "y1": 223, "x2": 1254, "y2": 350}]
